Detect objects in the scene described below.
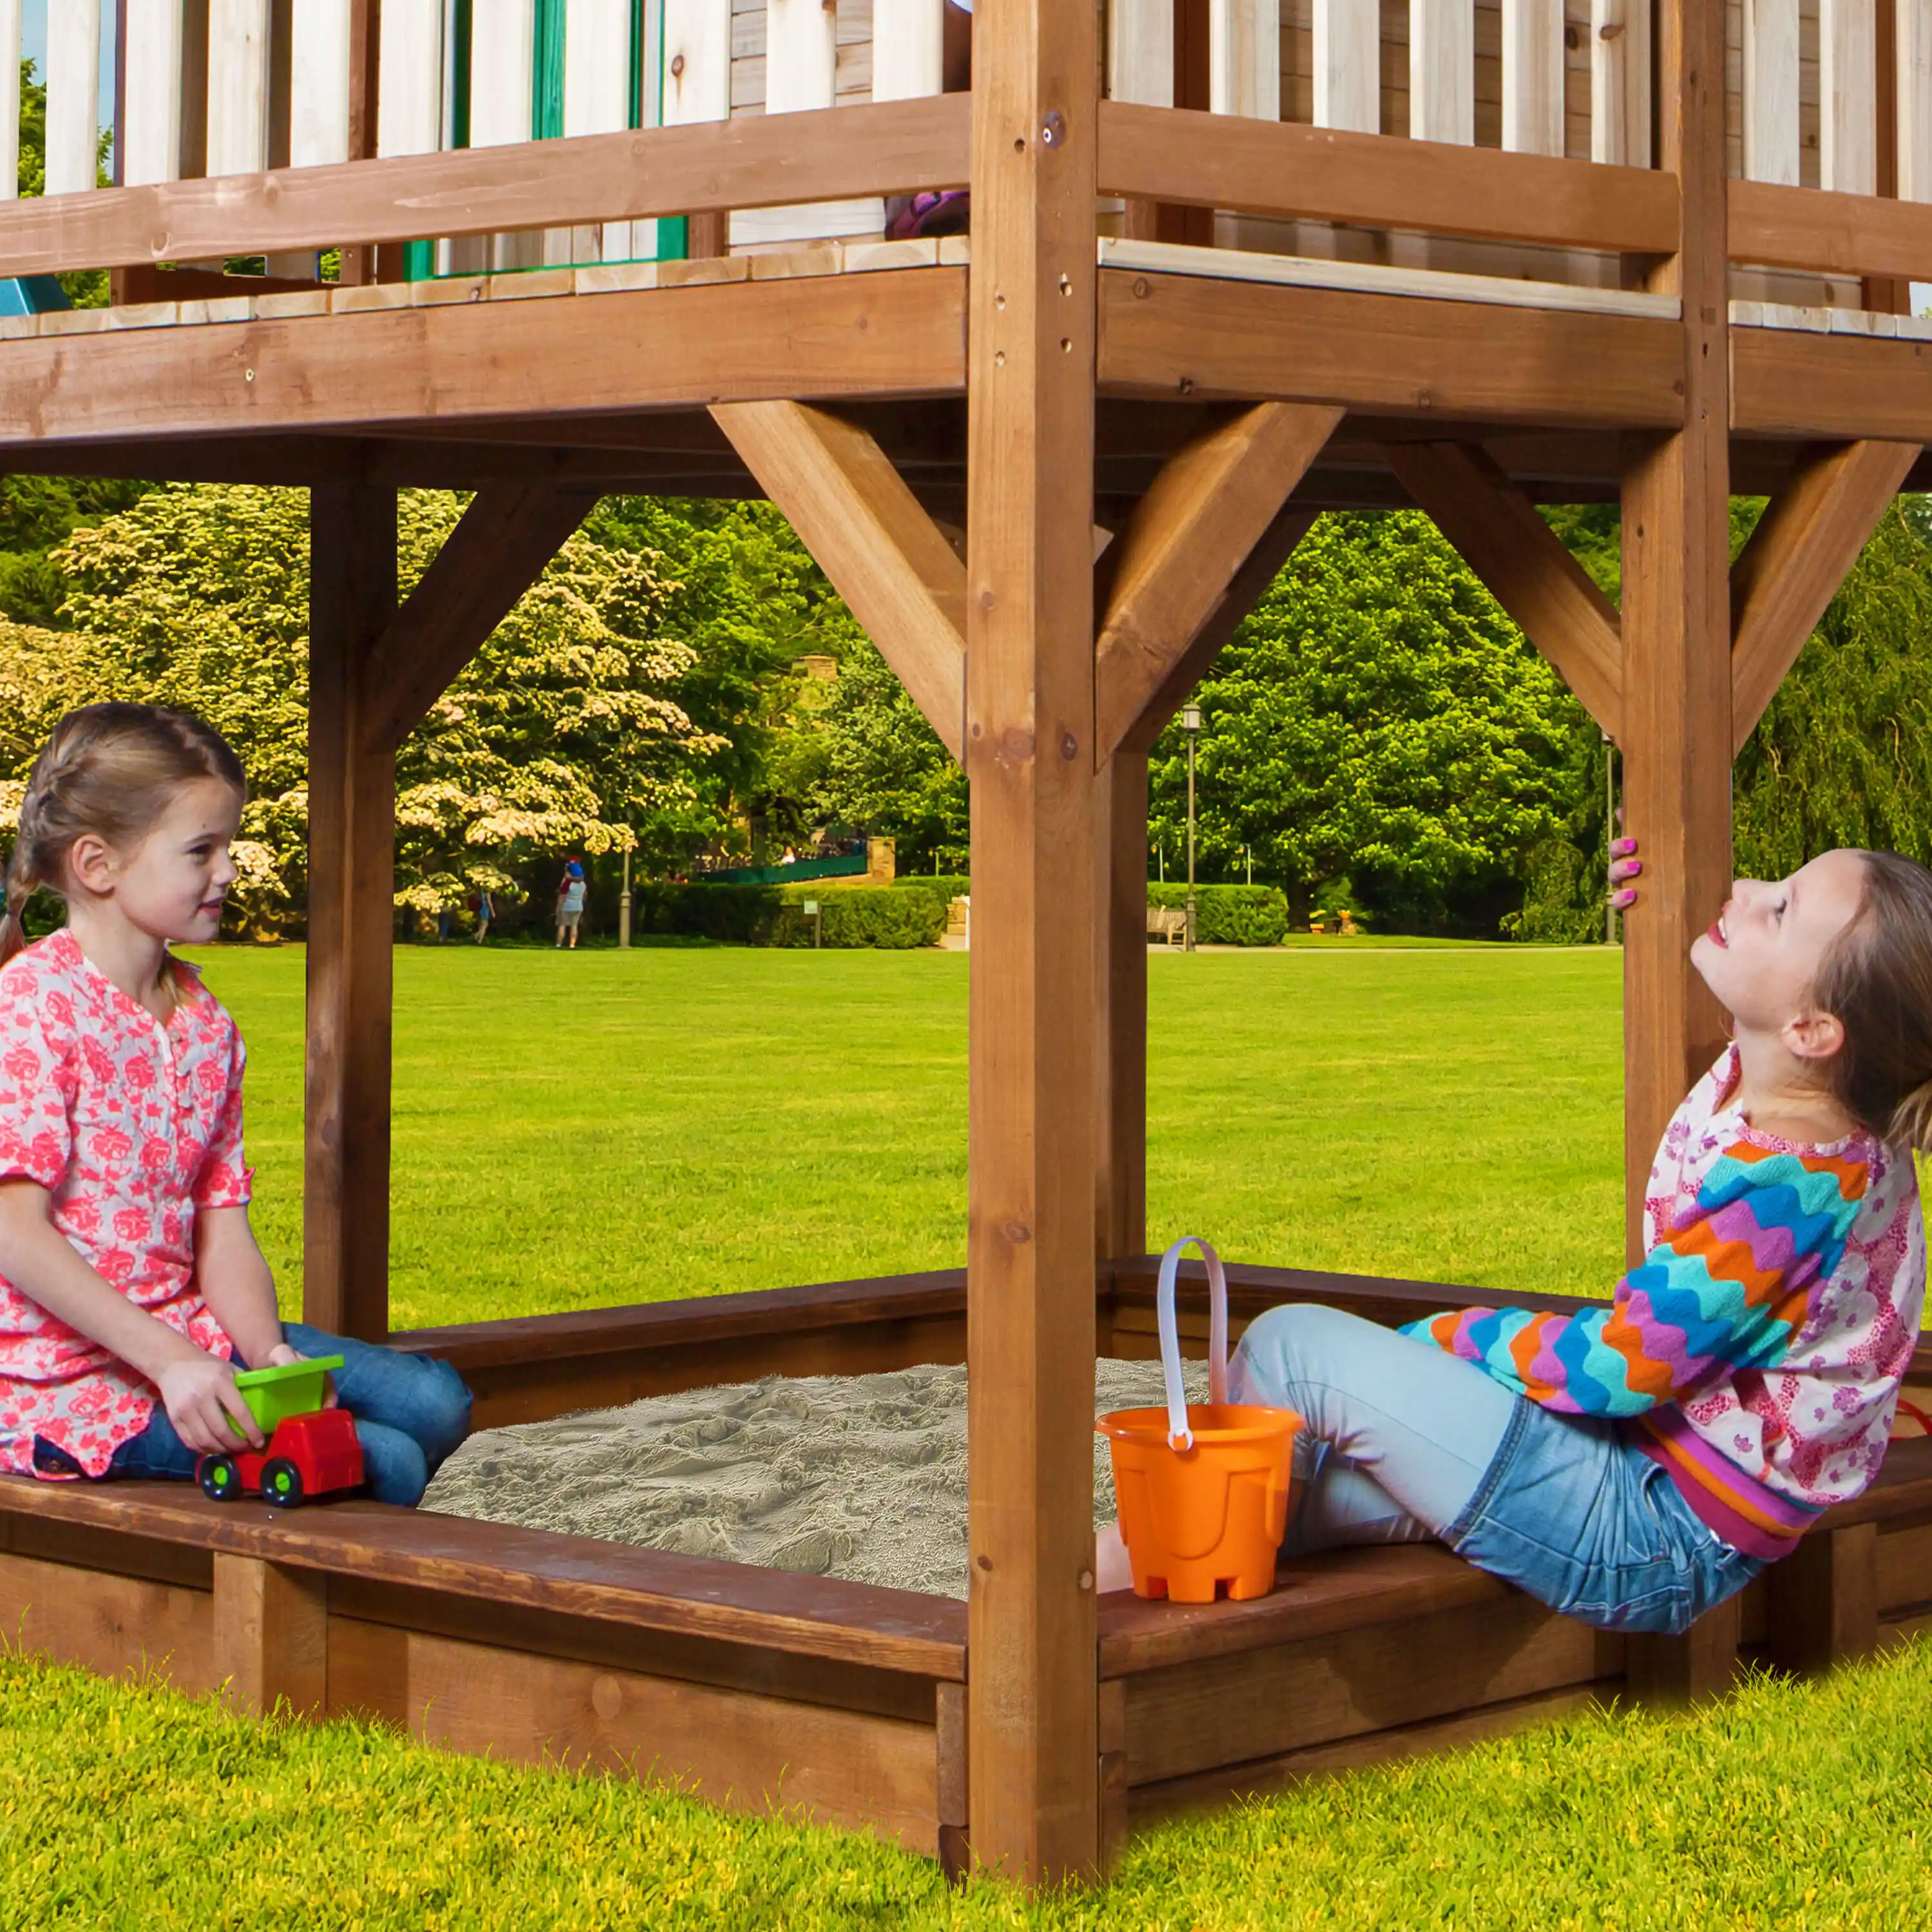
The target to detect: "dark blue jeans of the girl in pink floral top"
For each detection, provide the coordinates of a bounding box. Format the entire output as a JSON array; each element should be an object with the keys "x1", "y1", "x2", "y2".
[{"x1": 35, "y1": 1321, "x2": 469, "y2": 1505}]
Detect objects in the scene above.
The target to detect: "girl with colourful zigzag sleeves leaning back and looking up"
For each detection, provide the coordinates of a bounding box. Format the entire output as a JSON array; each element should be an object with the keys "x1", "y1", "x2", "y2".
[{"x1": 1128, "y1": 852, "x2": 1932, "y2": 1633}]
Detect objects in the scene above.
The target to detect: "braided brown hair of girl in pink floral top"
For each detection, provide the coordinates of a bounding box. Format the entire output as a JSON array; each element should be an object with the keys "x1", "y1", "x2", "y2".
[{"x1": 0, "y1": 703, "x2": 247, "y2": 966}]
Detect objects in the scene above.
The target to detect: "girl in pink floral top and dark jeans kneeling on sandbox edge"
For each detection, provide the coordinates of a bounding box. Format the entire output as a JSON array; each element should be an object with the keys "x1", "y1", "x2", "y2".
[{"x1": 0, "y1": 705, "x2": 469, "y2": 1503}]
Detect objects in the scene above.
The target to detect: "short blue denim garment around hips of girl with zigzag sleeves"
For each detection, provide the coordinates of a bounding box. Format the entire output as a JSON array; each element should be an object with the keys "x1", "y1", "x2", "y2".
[{"x1": 1443, "y1": 1399, "x2": 1764, "y2": 1636}]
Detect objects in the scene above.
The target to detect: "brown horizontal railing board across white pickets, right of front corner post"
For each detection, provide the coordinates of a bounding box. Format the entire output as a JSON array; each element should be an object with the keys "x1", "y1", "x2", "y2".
[{"x1": 1099, "y1": 100, "x2": 1685, "y2": 259}]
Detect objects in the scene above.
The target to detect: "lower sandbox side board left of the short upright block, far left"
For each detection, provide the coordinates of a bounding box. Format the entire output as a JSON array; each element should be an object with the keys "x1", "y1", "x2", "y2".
[{"x1": 0, "y1": 1538, "x2": 220, "y2": 1696}]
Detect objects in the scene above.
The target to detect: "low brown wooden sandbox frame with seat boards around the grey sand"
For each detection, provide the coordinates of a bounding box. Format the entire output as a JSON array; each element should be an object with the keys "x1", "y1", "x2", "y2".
[{"x1": 0, "y1": 1258, "x2": 1932, "y2": 1872}]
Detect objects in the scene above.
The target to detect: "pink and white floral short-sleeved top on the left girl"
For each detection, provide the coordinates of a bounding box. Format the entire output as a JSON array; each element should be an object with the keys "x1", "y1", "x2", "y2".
[{"x1": 0, "y1": 927, "x2": 253, "y2": 1476}]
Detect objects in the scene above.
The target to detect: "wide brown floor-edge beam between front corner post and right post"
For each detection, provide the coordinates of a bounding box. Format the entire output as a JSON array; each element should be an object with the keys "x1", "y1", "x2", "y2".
[{"x1": 1099, "y1": 265, "x2": 1685, "y2": 429}]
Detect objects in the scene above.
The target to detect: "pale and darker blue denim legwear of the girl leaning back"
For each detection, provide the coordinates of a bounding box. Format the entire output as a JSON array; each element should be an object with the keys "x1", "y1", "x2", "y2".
[{"x1": 1229, "y1": 1306, "x2": 1764, "y2": 1633}]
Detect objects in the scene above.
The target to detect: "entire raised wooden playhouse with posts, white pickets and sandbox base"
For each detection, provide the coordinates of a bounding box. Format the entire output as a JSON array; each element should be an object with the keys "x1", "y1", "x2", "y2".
[{"x1": 0, "y1": 0, "x2": 1932, "y2": 1882}]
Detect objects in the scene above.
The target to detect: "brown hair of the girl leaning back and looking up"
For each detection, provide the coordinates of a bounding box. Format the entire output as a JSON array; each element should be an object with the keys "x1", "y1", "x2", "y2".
[{"x1": 1812, "y1": 852, "x2": 1932, "y2": 1153}]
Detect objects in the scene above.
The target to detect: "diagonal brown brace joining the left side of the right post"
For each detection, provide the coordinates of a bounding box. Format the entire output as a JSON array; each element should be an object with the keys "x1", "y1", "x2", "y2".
[{"x1": 1387, "y1": 442, "x2": 1623, "y2": 738}]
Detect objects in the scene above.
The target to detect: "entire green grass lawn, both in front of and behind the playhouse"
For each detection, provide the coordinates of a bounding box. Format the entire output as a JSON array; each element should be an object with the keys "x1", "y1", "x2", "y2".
[{"x1": 0, "y1": 945, "x2": 1932, "y2": 1932}]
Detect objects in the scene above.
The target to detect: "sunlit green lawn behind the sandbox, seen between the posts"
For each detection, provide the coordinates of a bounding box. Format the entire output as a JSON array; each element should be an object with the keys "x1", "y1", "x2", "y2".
[{"x1": 184, "y1": 943, "x2": 1623, "y2": 1327}]
